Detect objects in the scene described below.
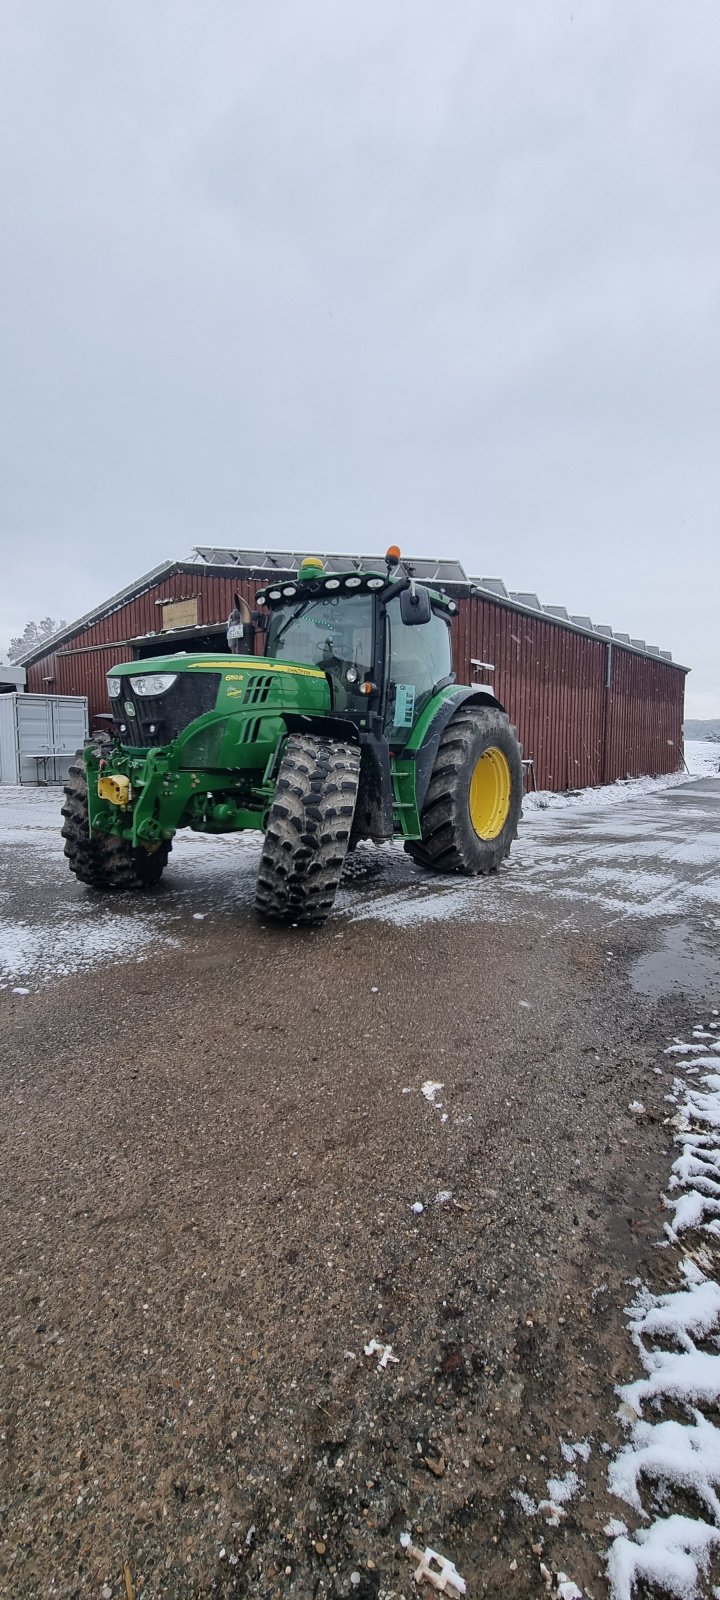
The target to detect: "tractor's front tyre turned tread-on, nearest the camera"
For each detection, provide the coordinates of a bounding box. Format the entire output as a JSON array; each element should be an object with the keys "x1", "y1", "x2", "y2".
[{"x1": 254, "y1": 734, "x2": 360, "y2": 925}]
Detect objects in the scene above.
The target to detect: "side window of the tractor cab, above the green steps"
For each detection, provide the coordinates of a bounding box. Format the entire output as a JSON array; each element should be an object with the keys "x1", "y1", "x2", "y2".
[{"x1": 386, "y1": 595, "x2": 453, "y2": 747}]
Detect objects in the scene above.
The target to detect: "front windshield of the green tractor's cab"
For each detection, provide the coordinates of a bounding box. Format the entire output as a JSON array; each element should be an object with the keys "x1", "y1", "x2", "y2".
[{"x1": 266, "y1": 595, "x2": 373, "y2": 683}]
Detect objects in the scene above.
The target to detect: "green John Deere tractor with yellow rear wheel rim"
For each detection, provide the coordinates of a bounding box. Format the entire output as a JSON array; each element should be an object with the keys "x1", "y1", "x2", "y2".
[{"x1": 62, "y1": 547, "x2": 523, "y2": 923}]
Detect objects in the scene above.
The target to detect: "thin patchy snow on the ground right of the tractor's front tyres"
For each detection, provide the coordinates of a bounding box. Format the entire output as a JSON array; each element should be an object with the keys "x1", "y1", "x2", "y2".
[{"x1": 345, "y1": 744, "x2": 720, "y2": 931}]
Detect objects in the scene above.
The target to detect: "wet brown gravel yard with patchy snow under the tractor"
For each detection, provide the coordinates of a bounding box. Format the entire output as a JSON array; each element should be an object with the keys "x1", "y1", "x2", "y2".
[{"x1": 0, "y1": 779, "x2": 720, "y2": 1600}]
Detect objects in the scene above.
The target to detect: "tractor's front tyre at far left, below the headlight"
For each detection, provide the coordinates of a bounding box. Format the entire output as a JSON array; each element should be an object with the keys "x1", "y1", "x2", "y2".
[{"x1": 62, "y1": 750, "x2": 171, "y2": 890}]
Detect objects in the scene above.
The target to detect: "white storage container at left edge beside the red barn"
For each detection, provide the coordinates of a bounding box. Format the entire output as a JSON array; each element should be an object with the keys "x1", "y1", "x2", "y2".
[{"x1": 0, "y1": 694, "x2": 88, "y2": 784}]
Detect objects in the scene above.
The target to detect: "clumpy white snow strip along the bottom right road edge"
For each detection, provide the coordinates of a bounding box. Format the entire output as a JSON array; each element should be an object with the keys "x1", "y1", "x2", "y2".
[{"x1": 608, "y1": 1011, "x2": 720, "y2": 1600}]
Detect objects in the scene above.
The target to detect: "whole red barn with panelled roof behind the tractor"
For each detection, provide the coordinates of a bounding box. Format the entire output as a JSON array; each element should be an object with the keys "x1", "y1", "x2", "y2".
[{"x1": 22, "y1": 547, "x2": 688, "y2": 789}]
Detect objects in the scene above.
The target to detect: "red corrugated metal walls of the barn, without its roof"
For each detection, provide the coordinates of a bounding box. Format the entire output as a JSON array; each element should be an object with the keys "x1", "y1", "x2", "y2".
[{"x1": 27, "y1": 566, "x2": 685, "y2": 789}]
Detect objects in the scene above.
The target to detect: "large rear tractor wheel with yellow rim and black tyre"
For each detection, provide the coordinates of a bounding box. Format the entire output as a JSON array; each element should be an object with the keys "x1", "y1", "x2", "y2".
[{"x1": 405, "y1": 706, "x2": 523, "y2": 877}]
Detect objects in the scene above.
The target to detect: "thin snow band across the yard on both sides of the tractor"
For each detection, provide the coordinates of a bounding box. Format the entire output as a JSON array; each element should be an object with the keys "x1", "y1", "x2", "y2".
[{"x1": 0, "y1": 742, "x2": 720, "y2": 987}]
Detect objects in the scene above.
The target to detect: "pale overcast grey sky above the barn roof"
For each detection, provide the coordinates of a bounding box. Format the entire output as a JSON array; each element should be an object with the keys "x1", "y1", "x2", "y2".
[{"x1": 0, "y1": 0, "x2": 720, "y2": 715}]
